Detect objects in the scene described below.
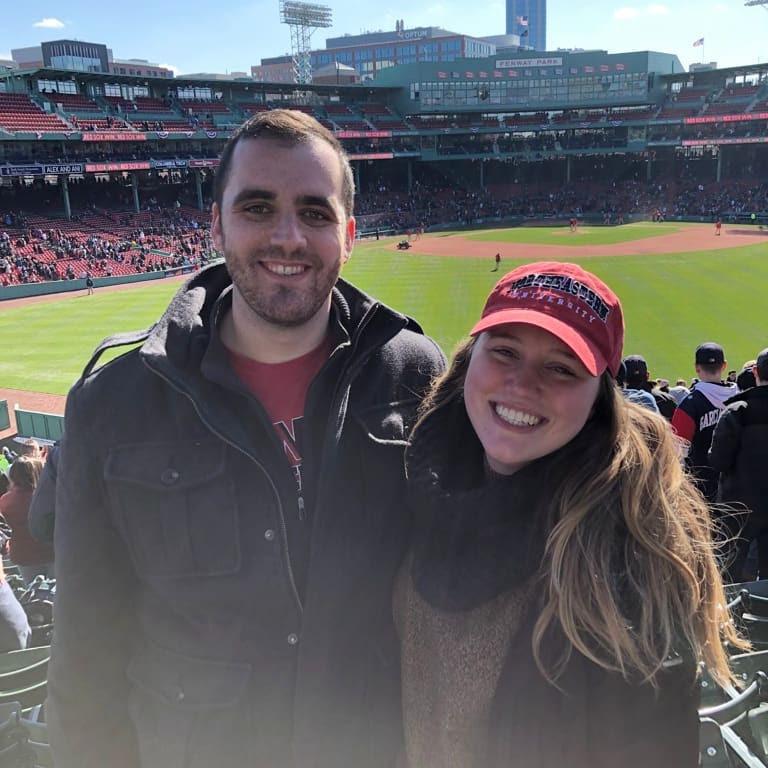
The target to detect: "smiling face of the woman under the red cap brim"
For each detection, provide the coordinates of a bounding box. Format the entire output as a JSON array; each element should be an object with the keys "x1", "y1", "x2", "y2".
[{"x1": 464, "y1": 323, "x2": 600, "y2": 475}]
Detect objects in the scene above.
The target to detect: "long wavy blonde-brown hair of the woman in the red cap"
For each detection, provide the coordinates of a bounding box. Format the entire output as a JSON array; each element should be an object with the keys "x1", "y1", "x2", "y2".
[{"x1": 421, "y1": 339, "x2": 749, "y2": 685}]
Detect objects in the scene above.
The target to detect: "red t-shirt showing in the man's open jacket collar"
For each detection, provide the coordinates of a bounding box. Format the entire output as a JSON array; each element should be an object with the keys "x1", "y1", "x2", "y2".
[{"x1": 229, "y1": 335, "x2": 332, "y2": 496}]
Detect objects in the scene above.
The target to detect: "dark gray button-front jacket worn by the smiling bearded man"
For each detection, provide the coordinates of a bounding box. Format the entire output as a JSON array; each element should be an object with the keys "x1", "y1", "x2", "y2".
[{"x1": 50, "y1": 266, "x2": 444, "y2": 768}]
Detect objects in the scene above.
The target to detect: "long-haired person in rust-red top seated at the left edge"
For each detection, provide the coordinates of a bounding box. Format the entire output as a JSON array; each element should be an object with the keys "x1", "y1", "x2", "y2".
[{"x1": 0, "y1": 456, "x2": 53, "y2": 583}]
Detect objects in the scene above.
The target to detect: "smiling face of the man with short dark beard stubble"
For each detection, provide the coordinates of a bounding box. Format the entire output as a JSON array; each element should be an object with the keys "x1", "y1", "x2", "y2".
[{"x1": 211, "y1": 138, "x2": 355, "y2": 327}]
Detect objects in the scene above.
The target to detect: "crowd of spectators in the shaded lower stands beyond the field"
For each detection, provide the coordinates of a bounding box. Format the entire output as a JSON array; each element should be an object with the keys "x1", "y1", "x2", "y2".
[{"x1": 0, "y1": 170, "x2": 768, "y2": 285}]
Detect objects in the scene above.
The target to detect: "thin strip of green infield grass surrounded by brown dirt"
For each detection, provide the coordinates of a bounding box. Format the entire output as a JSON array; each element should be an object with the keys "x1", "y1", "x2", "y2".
[{"x1": 466, "y1": 222, "x2": 680, "y2": 245}]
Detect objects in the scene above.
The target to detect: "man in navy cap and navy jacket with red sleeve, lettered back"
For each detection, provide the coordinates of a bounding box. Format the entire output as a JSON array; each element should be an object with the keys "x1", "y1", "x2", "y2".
[{"x1": 672, "y1": 342, "x2": 736, "y2": 503}]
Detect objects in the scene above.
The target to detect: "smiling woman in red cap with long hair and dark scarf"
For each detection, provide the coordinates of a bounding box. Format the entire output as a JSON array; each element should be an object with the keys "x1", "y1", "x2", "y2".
[{"x1": 394, "y1": 263, "x2": 746, "y2": 768}]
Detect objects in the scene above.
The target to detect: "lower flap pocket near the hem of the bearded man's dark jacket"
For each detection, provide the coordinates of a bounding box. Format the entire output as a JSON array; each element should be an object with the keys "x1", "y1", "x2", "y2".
[{"x1": 126, "y1": 645, "x2": 251, "y2": 712}]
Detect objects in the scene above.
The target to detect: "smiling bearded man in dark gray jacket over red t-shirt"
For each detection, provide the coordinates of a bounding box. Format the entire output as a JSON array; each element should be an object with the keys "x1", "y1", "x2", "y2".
[{"x1": 49, "y1": 110, "x2": 444, "y2": 768}]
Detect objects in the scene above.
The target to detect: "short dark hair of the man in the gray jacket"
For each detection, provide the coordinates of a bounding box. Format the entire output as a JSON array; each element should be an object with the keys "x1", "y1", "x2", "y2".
[{"x1": 213, "y1": 109, "x2": 355, "y2": 216}]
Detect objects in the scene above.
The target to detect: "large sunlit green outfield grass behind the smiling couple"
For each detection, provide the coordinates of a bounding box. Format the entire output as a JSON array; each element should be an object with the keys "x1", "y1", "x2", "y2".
[{"x1": 0, "y1": 231, "x2": 768, "y2": 394}]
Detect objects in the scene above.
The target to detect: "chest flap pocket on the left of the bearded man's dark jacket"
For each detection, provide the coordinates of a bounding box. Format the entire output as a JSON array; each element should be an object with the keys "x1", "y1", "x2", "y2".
[{"x1": 104, "y1": 440, "x2": 225, "y2": 491}]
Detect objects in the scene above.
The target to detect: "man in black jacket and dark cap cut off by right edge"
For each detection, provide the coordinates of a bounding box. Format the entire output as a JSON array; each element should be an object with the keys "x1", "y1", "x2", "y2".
[{"x1": 709, "y1": 348, "x2": 768, "y2": 582}]
